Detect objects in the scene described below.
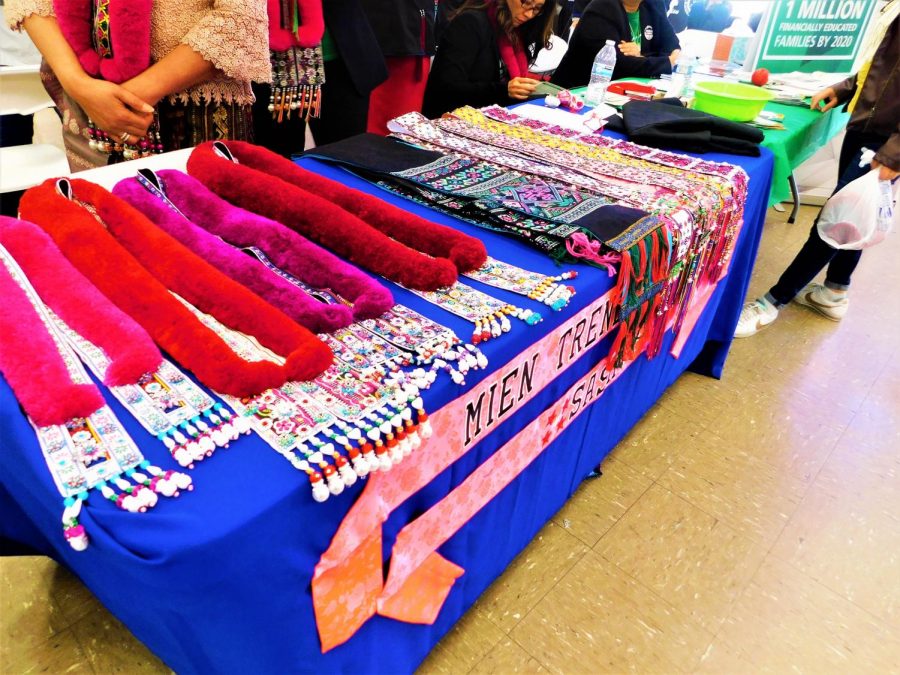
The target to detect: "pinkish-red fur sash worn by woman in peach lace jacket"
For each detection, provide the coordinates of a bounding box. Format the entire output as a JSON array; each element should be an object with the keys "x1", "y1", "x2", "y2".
[{"x1": 53, "y1": 0, "x2": 153, "y2": 83}]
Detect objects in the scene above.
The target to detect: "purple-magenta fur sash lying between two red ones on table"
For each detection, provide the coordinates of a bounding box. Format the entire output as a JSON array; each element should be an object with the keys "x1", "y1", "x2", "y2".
[{"x1": 113, "y1": 170, "x2": 394, "y2": 333}]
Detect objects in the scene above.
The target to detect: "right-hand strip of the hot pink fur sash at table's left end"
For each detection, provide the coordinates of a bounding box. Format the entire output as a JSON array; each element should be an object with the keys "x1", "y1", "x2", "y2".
[{"x1": 0, "y1": 217, "x2": 162, "y2": 386}]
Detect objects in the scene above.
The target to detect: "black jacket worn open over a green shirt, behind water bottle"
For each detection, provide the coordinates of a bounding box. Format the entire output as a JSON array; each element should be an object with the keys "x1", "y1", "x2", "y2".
[{"x1": 551, "y1": 0, "x2": 680, "y2": 88}]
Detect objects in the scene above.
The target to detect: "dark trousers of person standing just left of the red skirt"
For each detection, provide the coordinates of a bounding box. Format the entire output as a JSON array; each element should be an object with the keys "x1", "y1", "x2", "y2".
[{"x1": 309, "y1": 59, "x2": 369, "y2": 145}]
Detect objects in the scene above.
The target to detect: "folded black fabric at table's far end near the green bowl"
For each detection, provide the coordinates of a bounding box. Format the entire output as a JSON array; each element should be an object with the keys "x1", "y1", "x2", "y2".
[{"x1": 606, "y1": 99, "x2": 763, "y2": 157}]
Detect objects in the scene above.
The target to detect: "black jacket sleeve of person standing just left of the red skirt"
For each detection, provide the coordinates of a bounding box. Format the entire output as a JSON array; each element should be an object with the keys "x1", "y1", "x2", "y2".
[{"x1": 322, "y1": 0, "x2": 388, "y2": 96}]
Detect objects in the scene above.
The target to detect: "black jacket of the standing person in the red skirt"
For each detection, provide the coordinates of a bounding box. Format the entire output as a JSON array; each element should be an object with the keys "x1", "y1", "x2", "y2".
[{"x1": 362, "y1": 0, "x2": 438, "y2": 56}]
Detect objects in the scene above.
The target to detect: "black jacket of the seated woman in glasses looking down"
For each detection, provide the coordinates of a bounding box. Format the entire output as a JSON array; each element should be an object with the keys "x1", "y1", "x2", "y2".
[{"x1": 422, "y1": 10, "x2": 513, "y2": 118}]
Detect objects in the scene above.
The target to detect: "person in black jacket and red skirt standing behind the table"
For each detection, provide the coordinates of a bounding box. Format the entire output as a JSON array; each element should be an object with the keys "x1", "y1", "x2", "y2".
[{"x1": 362, "y1": 0, "x2": 438, "y2": 135}]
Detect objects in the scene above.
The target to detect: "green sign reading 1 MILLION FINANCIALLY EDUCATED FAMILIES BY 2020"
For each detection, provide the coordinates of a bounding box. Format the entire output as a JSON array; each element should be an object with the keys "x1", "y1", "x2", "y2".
[{"x1": 756, "y1": 0, "x2": 876, "y2": 73}]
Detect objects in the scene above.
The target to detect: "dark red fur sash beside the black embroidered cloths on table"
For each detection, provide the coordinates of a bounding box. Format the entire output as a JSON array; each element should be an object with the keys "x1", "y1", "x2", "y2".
[{"x1": 187, "y1": 141, "x2": 487, "y2": 291}]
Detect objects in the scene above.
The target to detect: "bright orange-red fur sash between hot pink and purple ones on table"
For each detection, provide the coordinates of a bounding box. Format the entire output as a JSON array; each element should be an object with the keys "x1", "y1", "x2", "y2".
[{"x1": 19, "y1": 179, "x2": 332, "y2": 396}]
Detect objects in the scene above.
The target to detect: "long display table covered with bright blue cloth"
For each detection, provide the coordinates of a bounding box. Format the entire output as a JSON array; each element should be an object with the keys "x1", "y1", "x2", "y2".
[{"x1": 0, "y1": 140, "x2": 772, "y2": 673}]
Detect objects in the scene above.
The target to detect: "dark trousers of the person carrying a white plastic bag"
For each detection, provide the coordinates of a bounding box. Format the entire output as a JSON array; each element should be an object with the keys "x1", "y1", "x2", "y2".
[{"x1": 768, "y1": 129, "x2": 887, "y2": 307}]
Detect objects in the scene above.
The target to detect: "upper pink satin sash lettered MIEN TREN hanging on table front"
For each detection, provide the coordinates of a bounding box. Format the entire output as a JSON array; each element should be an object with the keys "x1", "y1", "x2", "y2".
[{"x1": 312, "y1": 291, "x2": 614, "y2": 652}]
